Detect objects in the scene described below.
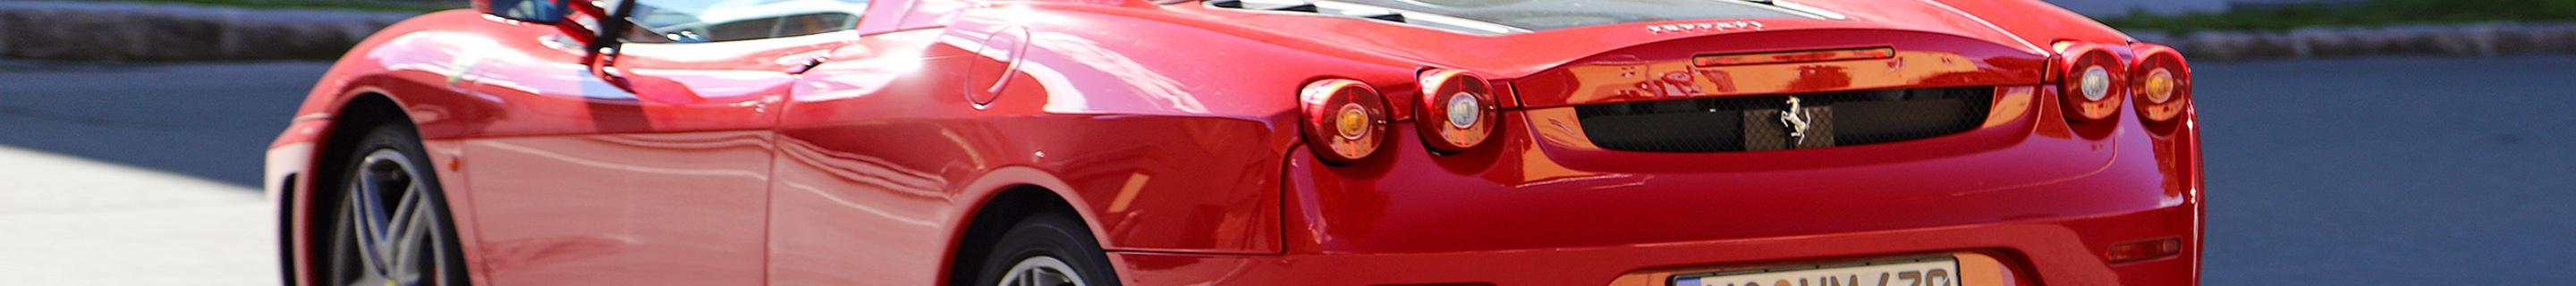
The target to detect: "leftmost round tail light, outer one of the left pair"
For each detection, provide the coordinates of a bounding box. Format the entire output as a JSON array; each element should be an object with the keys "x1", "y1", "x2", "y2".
[{"x1": 1299, "y1": 80, "x2": 1385, "y2": 163}]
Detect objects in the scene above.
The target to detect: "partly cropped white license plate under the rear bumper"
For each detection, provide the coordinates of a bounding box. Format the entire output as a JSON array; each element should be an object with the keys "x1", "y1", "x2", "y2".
[{"x1": 1672, "y1": 257, "x2": 1961, "y2": 286}]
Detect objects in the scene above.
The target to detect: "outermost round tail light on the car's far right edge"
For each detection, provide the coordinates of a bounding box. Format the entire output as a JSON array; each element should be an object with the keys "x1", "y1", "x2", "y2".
[{"x1": 2131, "y1": 44, "x2": 2192, "y2": 121}]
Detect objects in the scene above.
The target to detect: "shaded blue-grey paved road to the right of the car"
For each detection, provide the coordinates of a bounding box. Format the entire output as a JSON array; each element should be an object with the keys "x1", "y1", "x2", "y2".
[{"x1": 2195, "y1": 56, "x2": 2576, "y2": 286}]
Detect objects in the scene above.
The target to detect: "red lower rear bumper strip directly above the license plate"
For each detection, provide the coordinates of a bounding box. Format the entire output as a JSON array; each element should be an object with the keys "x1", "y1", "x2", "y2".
[{"x1": 1110, "y1": 204, "x2": 2200, "y2": 286}]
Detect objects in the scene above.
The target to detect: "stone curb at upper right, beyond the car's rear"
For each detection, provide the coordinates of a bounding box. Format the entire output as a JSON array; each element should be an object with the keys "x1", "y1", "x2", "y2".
[{"x1": 2131, "y1": 23, "x2": 2576, "y2": 59}]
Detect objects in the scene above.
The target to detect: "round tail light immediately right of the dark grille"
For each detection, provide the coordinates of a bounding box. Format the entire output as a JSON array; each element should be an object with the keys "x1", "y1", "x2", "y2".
[{"x1": 2050, "y1": 41, "x2": 2128, "y2": 121}]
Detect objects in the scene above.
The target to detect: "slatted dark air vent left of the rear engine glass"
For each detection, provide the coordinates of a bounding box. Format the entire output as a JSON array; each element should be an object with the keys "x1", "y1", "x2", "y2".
[{"x1": 1208, "y1": 0, "x2": 1530, "y2": 36}]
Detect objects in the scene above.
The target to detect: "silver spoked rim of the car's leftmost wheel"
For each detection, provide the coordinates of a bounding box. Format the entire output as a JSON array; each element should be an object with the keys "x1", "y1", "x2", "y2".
[{"x1": 333, "y1": 149, "x2": 445, "y2": 286}]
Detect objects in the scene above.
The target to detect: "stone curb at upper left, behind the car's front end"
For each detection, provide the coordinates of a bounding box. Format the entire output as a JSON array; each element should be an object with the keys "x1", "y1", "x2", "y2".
[{"x1": 0, "y1": 3, "x2": 415, "y2": 62}]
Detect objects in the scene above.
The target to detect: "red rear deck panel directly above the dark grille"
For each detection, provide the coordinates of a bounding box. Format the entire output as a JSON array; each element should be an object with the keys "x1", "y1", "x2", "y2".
[{"x1": 1513, "y1": 29, "x2": 2048, "y2": 108}]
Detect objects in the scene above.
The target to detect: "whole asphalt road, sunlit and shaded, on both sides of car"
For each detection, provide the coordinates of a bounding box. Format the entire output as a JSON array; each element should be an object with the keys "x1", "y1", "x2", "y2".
[{"x1": 0, "y1": 56, "x2": 2576, "y2": 286}]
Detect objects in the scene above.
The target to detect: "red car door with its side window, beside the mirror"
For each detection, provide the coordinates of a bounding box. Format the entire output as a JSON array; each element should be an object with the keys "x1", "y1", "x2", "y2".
[{"x1": 456, "y1": 0, "x2": 866, "y2": 286}]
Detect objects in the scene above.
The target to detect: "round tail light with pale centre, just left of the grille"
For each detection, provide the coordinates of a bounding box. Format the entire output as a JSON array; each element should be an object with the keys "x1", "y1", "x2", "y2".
[{"x1": 1414, "y1": 70, "x2": 1496, "y2": 152}]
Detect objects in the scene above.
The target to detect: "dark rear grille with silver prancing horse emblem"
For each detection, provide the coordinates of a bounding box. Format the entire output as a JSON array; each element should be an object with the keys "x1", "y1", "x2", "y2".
[{"x1": 1574, "y1": 88, "x2": 1994, "y2": 152}]
